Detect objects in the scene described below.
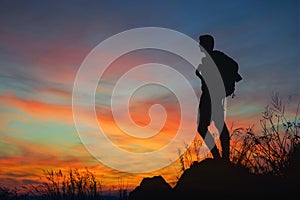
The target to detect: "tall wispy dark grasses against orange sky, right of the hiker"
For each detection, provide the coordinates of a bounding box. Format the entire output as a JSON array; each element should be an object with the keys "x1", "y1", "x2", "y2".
[{"x1": 231, "y1": 93, "x2": 300, "y2": 175}]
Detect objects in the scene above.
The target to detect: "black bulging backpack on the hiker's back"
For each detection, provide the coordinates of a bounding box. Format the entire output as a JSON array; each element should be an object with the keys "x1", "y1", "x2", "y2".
[{"x1": 211, "y1": 50, "x2": 242, "y2": 98}]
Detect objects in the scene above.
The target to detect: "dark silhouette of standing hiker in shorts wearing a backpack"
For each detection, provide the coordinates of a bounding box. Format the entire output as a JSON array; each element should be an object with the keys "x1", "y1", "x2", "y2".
[{"x1": 196, "y1": 35, "x2": 242, "y2": 162}]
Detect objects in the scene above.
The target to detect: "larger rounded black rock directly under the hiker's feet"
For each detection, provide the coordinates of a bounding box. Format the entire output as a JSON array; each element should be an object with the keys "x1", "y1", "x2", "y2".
[{"x1": 174, "y1": 159, "x2": 254, "y2": 199}]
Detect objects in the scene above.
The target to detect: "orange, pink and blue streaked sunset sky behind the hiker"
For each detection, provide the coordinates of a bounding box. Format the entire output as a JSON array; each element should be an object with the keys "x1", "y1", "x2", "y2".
[{"x1": 0, "y1": 0, "x2": 300, "y2": 191}]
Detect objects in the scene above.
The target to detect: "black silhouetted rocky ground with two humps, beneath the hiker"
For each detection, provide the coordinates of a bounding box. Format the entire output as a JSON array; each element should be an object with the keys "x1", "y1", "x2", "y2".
[{"x1": 129, "y1": 159, "x2": 300, "y2": 200}]
